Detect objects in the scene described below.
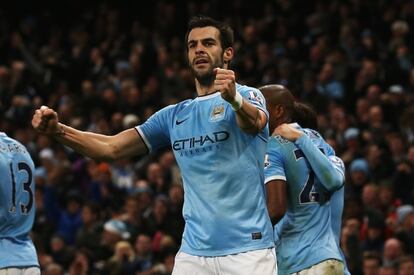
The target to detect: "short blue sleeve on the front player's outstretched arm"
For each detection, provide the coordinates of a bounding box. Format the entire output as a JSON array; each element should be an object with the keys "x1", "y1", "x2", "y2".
[{"x1": 135, "y1": 105, "x2": 175, "y2": 152}]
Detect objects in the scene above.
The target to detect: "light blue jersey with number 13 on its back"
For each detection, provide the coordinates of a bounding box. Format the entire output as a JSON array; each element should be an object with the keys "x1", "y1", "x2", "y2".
[{"x1": 0, "y1": 132, "x2": 39, "y2": 269}]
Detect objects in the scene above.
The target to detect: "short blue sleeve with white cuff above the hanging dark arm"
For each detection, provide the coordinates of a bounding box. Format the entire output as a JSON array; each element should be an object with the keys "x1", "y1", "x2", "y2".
[{"x1": 264, "y1": 137, "x2": 286, "y2": 183}]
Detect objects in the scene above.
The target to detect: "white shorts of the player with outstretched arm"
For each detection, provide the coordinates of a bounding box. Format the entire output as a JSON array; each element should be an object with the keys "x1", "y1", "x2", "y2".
[{"x1": 172, "y1": 248, "x2": 277, "y2": 275}]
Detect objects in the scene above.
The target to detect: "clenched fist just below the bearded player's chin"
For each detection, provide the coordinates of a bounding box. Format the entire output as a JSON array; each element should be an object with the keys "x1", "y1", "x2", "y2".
[{"x1": 214, "y1": 68, "x2": 236, "y2": 103}]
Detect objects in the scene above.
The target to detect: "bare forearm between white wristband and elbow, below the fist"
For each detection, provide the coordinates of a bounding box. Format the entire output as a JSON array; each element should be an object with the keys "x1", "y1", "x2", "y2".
[{"x1": 235, "y1": 99, "x2": 267, "y2": 134}]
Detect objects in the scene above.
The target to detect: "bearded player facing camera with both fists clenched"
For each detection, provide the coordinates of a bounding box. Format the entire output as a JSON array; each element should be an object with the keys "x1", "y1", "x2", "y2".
[{"x1": 32, "y1": 17, "x2": 276, "y2": 275}]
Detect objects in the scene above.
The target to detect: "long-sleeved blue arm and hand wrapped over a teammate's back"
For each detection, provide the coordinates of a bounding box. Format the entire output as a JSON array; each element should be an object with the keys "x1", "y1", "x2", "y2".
[{"x1": 274, "y1": 124, "x2": 344, "y2": 191}]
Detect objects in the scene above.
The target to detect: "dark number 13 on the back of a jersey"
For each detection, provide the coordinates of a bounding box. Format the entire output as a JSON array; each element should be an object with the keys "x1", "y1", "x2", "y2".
[{"x1": 9, "y1": 162, "x2": 33, "y2": 214}]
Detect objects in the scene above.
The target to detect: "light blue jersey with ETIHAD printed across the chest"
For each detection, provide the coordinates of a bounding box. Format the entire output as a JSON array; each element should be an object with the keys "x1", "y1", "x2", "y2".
[{"x1": 137, "y1": 85, "x2": 274, "y2": 256}]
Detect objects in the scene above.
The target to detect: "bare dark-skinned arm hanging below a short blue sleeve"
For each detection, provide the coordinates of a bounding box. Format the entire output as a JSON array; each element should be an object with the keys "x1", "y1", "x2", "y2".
[{"x1": 266, "y1": 180, "x2": 286, "y2": 225}]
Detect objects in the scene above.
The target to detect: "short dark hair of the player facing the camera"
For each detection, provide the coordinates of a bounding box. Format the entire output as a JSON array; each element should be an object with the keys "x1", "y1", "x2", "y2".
[{"x1": 184, "y1": 15, "x2": 234, "y2": 51}]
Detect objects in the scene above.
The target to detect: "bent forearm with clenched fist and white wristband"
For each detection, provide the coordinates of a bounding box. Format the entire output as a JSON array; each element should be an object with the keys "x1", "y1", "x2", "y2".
[{"x1": 214, "y1": 68, "x2": 267, "y2": 134}]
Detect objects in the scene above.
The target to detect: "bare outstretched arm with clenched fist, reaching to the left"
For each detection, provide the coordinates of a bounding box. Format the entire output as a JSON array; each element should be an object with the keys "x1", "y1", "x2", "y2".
[{"x1": 32, "y1": 106, "x2": 148, "y2": 161}]
